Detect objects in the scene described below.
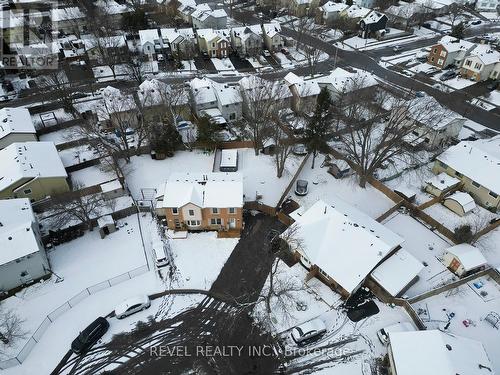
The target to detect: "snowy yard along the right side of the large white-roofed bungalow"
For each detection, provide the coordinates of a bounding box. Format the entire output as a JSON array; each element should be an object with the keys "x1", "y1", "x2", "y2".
[{"x1": 383, "y1": 213, "x2": 455, "y2": 297}]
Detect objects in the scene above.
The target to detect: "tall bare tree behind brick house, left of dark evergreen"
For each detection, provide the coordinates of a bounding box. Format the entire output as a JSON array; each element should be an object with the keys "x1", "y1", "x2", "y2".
[{"x1": 240, "y1": 76, "x2": 289, "y2": 155}]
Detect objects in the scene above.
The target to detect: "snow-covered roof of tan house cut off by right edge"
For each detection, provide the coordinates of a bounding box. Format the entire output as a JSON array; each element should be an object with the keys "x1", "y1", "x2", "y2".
[{"x1": 437, "y1": 135, "x2": 500, "y2": 194}]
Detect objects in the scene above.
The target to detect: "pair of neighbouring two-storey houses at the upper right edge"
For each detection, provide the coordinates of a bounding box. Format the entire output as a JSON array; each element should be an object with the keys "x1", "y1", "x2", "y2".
[{"x1": 427, "y1": 36, "x2": 500, "y2": 81}]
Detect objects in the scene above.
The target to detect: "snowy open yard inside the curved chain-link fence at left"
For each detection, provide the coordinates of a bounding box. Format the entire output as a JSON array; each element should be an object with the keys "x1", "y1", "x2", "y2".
[{"x1": 2, "y1": 216, "x2": 148, "y2": 362}]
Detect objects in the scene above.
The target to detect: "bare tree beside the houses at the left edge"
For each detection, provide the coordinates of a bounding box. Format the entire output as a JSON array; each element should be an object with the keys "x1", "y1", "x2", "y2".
[{"x1": 50, "y1": 181, "x2": 105, "y2": 230}]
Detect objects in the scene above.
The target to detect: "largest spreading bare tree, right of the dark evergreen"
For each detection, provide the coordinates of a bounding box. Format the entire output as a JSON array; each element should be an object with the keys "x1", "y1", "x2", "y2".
[{"x1": 337, "y1": 79, "x2": 443, "y2": 187}]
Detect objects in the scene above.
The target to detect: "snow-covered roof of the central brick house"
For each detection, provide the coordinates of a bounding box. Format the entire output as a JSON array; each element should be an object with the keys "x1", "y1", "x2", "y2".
[{"x1": 162, "y1": 172, "x2": 243, "y2": 208}]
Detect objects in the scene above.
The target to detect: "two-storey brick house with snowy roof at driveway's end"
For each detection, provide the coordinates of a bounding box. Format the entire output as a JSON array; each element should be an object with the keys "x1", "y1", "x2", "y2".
[{"x1": 156, "y1": 173, "x2": 243, "y2": 234}]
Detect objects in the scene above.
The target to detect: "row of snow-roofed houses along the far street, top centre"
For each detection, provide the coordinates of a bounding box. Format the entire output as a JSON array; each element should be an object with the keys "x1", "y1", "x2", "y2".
[{"x1": 139, "y1": 22, "x2": 283, "y2": 58}]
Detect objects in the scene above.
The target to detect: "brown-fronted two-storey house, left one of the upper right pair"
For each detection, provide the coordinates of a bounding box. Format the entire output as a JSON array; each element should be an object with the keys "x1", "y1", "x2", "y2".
[{"x1": 427, "y1": 35, "x2": 476, "y2": 69}]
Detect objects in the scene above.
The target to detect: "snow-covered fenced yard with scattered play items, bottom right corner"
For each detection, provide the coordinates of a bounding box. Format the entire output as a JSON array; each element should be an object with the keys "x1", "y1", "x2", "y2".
[{"x1": 413, "y1": 276, "x2": 500, "y2": 373}]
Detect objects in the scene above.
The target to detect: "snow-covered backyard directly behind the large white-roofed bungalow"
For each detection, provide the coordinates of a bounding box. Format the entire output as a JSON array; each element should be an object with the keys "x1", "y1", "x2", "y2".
[{"x1": 290, "y1": 155, "x2": 394, "y2": 218}]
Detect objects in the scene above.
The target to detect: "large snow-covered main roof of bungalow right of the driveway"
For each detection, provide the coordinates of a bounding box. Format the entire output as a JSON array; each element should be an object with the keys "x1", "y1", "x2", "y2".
[{"x1": 285, "y1": 198, "x2": 404, "y2": 293}]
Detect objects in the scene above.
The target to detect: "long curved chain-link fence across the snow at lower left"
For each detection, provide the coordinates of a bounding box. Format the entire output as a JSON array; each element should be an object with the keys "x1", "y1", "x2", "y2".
[{"x1": 0, "y1": 265, "x2": 149, "y2": 370}]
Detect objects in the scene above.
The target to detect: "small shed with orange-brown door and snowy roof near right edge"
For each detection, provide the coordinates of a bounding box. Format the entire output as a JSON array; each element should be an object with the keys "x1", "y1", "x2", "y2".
[{"x1": 443, "y1": 244, "x2": 488, "y2": 277}]
